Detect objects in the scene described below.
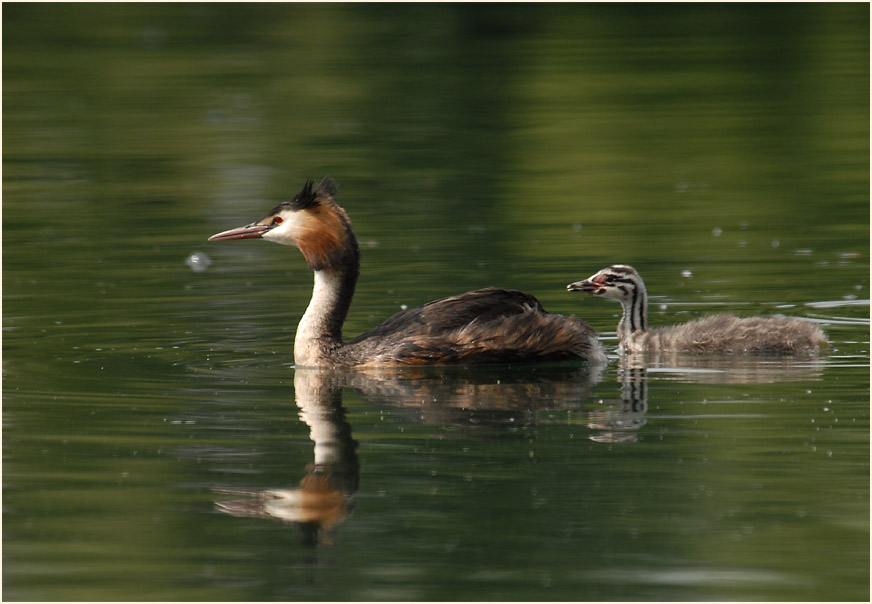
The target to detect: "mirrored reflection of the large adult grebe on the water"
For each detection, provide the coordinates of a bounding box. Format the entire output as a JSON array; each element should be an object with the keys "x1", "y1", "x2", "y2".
[{"x1": 214, "y1": 366, "x2": 602, "y2": 547}]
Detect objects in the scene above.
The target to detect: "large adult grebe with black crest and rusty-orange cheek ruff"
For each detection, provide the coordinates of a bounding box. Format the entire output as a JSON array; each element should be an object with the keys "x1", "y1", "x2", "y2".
[{"x1": 209, "y1": 177, "x2": 606, "y2": 367}]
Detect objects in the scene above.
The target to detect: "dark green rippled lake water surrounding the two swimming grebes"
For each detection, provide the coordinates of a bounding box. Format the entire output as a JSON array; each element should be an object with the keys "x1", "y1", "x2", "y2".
[{"x1": 3, "y1": 4, "x2": 870, "y2": 601}]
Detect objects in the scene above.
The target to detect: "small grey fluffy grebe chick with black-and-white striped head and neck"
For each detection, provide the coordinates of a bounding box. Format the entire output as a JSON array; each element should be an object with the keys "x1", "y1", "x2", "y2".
[{"x1": 566, "y1": 264, "x2": 827, "y2": 354}]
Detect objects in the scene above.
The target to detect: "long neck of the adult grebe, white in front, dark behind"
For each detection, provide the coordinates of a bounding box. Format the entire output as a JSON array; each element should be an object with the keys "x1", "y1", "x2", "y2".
[{"x1": 294, "y1": 255, "x2": 360, "y2": 367}]
